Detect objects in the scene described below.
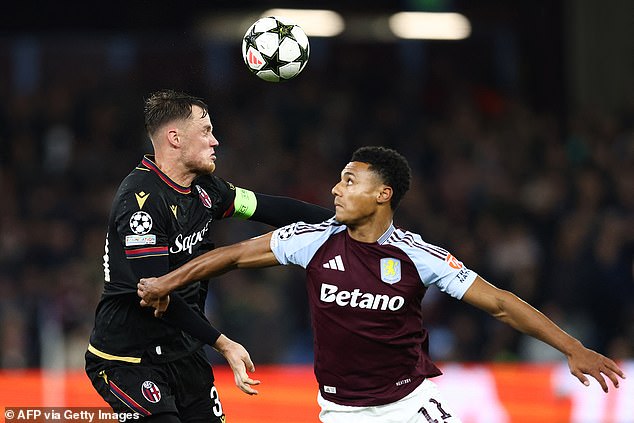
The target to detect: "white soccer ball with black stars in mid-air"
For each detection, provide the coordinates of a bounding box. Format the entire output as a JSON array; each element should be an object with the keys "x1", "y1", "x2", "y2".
[{"x1": 242, "y1": 16, "x2": 310, "y2": 82}]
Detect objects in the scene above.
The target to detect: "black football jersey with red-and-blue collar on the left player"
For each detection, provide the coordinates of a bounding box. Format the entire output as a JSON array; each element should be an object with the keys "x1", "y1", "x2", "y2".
[{"x1": 89, "y1": 156, "x2": 236, "y2": 362}]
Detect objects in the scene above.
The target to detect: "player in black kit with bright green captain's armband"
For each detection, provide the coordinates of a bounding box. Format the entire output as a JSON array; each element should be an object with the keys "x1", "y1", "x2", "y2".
[{"x1": 86, "y1": 90, "x2": 332, "y2": 422}]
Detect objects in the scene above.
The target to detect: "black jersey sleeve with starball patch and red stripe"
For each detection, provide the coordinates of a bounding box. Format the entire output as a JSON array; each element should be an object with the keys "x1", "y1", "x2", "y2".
[{"x1": 114, "y1": 189, "x2": 169, "y2": 280}]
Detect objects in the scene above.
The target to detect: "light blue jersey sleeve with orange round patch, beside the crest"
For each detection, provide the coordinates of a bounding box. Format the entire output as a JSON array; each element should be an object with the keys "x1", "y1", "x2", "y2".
[{"x1": 408, "y1": 235, "x2": 477, "y2": 300}]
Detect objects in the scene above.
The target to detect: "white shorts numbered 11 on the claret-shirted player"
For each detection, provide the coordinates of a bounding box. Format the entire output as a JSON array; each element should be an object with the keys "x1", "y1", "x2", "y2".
[{"x1": 317, "y1": 379, "x2": 461, "y2": 423}]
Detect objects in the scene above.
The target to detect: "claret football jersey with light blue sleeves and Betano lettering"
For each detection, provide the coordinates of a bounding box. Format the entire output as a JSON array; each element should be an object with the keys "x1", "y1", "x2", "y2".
[{"x1": 271, "y1": 218, "x2": 476, "y2": 406}]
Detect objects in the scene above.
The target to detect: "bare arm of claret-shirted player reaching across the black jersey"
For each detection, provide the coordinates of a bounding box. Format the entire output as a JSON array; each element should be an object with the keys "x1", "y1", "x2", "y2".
[{"x1": 137, "y1": 232, "x2": 279, "y2": 314}]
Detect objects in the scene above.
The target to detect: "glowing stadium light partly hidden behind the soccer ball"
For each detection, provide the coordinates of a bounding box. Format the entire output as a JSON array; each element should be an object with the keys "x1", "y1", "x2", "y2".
[{"x1": 262, "y1": 9, "x2": 345, "y2": 37}]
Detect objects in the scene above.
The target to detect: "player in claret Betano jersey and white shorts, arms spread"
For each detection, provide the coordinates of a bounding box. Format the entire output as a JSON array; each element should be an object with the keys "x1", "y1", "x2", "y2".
[{"x1": 139, "y1": 147, "x2": 624, "y2": 423}]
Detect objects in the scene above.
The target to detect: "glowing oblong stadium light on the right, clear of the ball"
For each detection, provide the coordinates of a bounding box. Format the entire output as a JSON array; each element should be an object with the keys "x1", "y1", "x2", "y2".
[{"x1": 389, "y1": 12, "x2": 471, "y2": 40}]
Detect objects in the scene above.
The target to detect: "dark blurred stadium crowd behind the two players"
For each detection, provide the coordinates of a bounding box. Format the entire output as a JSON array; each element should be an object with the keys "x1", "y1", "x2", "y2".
[{"x1": 0, "y1": 22, "x2": 634, "y2": 368}]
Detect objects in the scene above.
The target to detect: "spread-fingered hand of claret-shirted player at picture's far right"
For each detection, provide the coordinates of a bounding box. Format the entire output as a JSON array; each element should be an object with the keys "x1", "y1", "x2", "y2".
[{"x1": 568, "y1": 346, "x2": 625, "y2": 392}]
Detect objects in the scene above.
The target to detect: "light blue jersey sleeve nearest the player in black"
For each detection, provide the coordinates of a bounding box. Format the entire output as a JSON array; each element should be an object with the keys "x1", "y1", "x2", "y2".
[{"x1": 271, "y1": 220, "x2": 332, "y2": 268}]
